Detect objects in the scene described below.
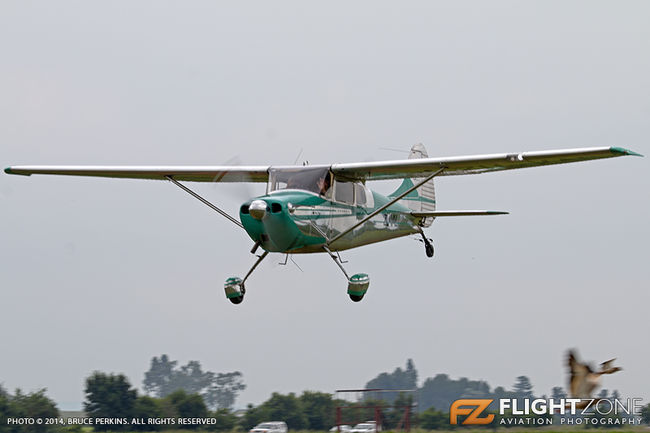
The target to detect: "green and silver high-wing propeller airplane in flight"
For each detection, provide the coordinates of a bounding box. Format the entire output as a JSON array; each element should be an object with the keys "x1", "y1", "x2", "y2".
[{"x1": 5, "y1": 144, "x2": 641, "y2": 304}]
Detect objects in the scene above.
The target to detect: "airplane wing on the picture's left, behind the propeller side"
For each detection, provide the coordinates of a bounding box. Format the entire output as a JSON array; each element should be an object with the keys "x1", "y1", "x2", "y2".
[{"x1": 5, "y1": 165, "x2": 269, "y2": 182}]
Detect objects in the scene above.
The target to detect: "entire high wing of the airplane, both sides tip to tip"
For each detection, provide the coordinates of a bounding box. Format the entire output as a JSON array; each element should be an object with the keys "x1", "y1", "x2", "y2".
[{"x1": 5, "y1": 147, "x2": 638, "y2": 182}]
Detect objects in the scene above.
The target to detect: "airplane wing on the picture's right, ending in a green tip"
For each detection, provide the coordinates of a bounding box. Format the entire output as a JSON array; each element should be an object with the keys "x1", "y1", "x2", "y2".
[{"x1": 332, "y1": 147, "x2": 642, "y2": 180}]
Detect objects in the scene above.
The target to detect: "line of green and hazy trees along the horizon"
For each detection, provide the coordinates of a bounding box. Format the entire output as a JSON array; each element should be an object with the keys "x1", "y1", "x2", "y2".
[{"x1": 0, "y1": 355, "x2": 650, "y2": 433}]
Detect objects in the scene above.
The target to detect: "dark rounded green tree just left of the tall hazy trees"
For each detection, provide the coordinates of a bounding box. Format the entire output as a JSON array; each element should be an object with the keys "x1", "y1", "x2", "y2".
[{"x1": 84, "y1": 371, "x2": 137, "y2": 431}]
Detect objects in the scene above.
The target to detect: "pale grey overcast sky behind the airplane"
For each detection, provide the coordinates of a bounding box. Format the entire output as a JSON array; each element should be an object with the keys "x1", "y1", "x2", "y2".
[{"x1": 0, "y1": 0, "x2": 650, "y2": 409}]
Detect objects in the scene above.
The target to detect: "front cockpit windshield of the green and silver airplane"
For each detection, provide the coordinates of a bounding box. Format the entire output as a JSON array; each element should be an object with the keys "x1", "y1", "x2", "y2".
[{"x1": 268, "y1": 167, "x2": 332, "y2": 196}]
